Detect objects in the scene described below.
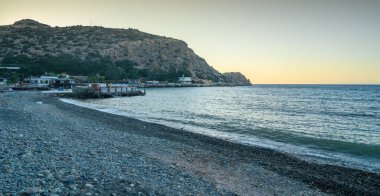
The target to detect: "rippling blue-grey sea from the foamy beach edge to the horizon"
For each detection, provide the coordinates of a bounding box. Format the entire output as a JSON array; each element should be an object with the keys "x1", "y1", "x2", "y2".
[{"x1": 62, "y1": 85, "x2": 380, "y2": 172}]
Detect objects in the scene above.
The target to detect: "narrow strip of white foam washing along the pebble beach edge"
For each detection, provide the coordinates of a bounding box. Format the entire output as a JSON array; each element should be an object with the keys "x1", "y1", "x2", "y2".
[{"x1": 60, "y1": 98, "x2": 380, "y2": 173}]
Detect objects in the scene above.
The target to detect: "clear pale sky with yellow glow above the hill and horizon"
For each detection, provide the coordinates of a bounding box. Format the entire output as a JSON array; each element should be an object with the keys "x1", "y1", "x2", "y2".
[{"x1": 0, "y1": 0, "x2": 380, "y2": 84}]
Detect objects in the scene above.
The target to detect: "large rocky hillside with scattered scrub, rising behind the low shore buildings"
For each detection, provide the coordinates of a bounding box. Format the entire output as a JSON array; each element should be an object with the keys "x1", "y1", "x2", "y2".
[{"x1": 0, "y1": 19, "x2": 252, "y2": 83}]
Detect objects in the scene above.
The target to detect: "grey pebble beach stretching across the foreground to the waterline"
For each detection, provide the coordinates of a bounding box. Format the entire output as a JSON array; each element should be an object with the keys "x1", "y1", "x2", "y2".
[{"x1": 0, "y1": 92, "x2": 380, "y2": 195}]
